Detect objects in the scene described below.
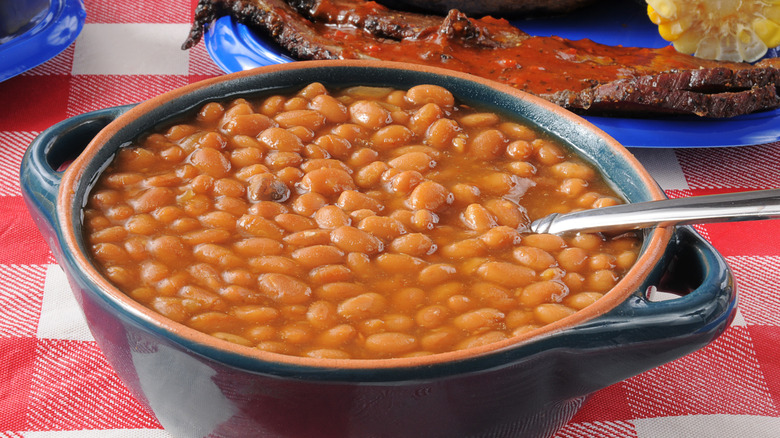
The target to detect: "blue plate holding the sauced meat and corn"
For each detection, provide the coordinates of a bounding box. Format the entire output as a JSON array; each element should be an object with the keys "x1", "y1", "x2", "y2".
[{"x1": 204, "y1": 0, "x2": 780, "y2": 148}]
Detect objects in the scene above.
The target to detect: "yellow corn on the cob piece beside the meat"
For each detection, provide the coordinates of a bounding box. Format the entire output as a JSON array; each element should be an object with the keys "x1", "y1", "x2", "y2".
[{"x1": 646, "y1": 0, "x2": 780, "y2": 62}]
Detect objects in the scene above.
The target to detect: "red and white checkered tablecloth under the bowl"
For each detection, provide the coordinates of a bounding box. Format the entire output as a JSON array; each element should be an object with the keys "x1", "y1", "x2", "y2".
[{"x1": 0, "y1": 0, "x2": 780, "y2": 438}]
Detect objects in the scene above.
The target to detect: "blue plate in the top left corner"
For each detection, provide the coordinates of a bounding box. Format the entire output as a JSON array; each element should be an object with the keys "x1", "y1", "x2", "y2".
[{"x1": 0, "y1": 0, "x2": 87, "y2": 81}]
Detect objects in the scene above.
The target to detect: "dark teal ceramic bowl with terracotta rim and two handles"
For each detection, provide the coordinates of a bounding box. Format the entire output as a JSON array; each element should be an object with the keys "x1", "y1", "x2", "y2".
[{"x1": 21, "y1": 61, "x2": 736, "y2": 438}]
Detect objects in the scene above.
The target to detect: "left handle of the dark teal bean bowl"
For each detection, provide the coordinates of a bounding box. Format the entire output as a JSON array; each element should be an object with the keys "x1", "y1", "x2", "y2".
[{"x1": 20, "y1": 105, "x2": 134, "y2": 226}]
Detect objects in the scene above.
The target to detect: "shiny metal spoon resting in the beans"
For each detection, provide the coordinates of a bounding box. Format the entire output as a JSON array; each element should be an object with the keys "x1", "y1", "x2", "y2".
[{"x1": 529, "y1": 189, "x2": 780, "y2": 234}]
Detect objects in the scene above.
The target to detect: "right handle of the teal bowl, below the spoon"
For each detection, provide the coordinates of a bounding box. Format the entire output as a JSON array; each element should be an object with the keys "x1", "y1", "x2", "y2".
[{"x1": 575, "y1": 226, "x2": 737, "y2": 349}]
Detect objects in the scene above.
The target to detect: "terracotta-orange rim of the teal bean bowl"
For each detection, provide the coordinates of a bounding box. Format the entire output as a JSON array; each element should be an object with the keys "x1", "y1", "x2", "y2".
[{"x1": 56, "y1": 60, "x2": 672, "y2": 370}]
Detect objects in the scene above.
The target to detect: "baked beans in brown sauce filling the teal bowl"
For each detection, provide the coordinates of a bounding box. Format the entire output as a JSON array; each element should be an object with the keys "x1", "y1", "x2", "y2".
[{"x1": 84, "y1": 83, "x2": 641, "y2": 359}]
